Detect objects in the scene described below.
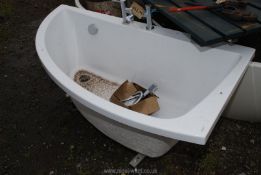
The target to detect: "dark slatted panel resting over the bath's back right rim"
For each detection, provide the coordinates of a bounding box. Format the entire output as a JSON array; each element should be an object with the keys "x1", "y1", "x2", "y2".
[{"x1": 148, "y1": 0, "x2": 261, "y2": 46}]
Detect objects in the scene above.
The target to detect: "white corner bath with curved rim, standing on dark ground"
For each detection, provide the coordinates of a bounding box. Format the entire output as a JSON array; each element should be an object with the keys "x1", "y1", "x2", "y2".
[{"x1": 36, "y1": 5, "x2": 255, "y2": 157}]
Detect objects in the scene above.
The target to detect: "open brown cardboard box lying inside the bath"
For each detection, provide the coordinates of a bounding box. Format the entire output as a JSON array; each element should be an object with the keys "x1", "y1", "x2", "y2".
[{"x1": 110, "y1": 81, "x2": 159, "y2": 115}]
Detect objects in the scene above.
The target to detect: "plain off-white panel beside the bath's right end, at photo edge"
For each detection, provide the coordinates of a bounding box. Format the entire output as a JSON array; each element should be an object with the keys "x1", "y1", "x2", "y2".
[{"x1": 223, "y1": 62, "x2": 261, "y2": 122}]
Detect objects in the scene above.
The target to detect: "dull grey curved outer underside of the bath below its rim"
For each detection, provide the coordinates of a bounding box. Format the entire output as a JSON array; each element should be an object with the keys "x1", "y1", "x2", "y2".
[{"x1": 72, "y1": 99, "x2": 178, "y2": 158}]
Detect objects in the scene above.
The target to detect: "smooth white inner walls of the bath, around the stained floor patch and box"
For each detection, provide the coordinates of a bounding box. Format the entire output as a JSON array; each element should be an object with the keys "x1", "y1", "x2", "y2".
[{"x1": 45, "y1": 10, "x2": 248, "y2": 118}]
